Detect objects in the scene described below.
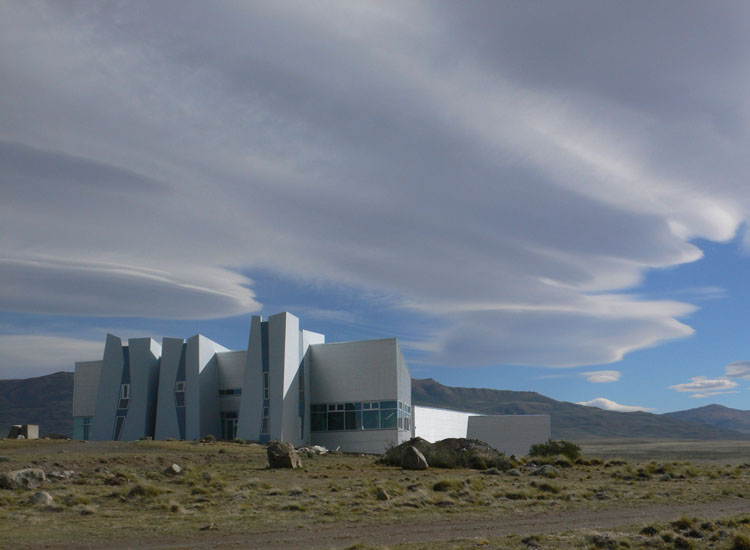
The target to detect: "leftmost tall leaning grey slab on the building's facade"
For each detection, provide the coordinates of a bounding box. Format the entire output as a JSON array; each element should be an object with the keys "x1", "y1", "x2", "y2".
[{"x1": 91, "y1": 334, "x2": 127, "y2": 441}]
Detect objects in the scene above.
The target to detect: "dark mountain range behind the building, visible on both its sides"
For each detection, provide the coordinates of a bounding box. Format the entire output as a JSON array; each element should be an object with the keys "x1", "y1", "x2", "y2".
[{"x1": 0, "y1": 372, "x2": 750, "y2": 440}]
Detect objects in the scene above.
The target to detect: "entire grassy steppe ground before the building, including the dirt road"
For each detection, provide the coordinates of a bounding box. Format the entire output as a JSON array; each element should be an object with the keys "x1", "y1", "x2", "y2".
[{"x1": 0, "y1": 440, "x2": 750, "y2": 550}]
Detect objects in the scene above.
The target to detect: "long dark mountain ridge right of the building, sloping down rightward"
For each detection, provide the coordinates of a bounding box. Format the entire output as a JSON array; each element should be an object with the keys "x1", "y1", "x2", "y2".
[{"x1": 411, "y1": 378, "x2": 750, "y2": 440}]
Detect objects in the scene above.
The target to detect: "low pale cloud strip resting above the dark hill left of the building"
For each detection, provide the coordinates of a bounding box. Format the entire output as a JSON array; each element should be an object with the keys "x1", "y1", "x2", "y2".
[{"x1": 0, "y1": 334, "x2": 104, "y2": 379}]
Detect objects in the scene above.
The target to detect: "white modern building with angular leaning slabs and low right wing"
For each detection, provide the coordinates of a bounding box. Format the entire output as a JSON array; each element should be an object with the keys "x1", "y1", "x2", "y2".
[{"x1": 73, "y1": 312, "x2": 549, "y2": 454}]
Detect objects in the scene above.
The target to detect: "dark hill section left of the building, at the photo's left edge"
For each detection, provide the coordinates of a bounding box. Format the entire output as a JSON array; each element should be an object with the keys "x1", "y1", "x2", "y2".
[{"x1": 0, "y1": 372, "x2": 73, "y2": 437}]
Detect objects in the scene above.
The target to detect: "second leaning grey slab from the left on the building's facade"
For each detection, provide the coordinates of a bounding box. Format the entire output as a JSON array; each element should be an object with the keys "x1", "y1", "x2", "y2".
[{"x1": 120, "y1": 338, "x2": 161, "y2": 441}]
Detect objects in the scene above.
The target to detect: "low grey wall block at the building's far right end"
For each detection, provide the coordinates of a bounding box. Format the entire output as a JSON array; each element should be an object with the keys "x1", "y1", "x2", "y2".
[{"x1": 468, "y1": 414, "x2": 551, "y2": 456}]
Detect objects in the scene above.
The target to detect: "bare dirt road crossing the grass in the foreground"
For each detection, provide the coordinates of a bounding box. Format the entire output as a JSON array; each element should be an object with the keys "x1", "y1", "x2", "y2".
[{"x1": 20, "y1": 498, "x2": 750, "y2": 550}]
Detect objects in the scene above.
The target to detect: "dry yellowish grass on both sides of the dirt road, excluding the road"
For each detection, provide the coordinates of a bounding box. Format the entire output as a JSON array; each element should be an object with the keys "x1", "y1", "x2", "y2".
[{"x1": 0, "y1": 440, "x2": 750, "y2": 549}]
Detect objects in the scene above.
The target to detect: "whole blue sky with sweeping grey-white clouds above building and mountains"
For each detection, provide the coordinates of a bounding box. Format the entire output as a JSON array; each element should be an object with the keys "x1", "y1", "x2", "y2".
[{"x1": 0, "y1": 0, "x2": 750, "y2": 413}]
